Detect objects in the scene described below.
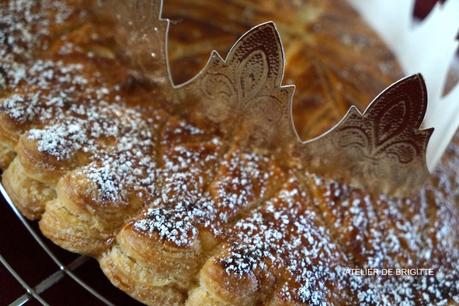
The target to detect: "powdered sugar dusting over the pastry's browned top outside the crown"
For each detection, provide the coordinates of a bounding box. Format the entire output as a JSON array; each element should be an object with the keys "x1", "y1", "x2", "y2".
[{"x1": 0, "y1": 0, "x2": 459, "y2": 305}]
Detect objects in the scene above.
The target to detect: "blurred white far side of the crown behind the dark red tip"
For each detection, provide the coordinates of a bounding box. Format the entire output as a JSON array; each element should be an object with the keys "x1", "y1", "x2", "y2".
[{"x1": 349, "y1": 0, "x2": 459, "y2": 171}]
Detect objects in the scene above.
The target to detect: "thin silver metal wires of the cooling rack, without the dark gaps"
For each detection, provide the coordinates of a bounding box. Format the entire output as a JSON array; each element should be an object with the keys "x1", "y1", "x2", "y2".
[{"x1": 0, "y1": 183, "x2": 114, "y2": 305}]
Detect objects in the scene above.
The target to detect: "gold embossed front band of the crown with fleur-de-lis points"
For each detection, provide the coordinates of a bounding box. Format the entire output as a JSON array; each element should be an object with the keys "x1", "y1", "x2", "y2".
[{"x1": 100, "y1": 0, "x2": 459, "y2": 196}]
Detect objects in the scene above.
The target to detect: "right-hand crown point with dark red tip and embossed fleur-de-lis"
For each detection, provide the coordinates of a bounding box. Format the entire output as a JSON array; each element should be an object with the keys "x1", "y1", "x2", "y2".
[{"x1": 300, "y1": 75, "x2": 433, "y2": 195}]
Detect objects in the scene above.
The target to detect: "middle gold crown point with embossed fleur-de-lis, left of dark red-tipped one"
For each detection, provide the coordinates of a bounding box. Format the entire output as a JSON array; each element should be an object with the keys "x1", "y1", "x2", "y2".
[{"x1": 178, "y1": 22, "x2": 293, "y2": 144}]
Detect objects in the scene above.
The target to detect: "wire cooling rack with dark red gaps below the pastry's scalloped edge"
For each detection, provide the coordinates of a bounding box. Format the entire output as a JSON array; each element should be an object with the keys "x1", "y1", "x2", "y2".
[{"x1": 0, "y1": 184, "x2": 144, "y2": 305}]
